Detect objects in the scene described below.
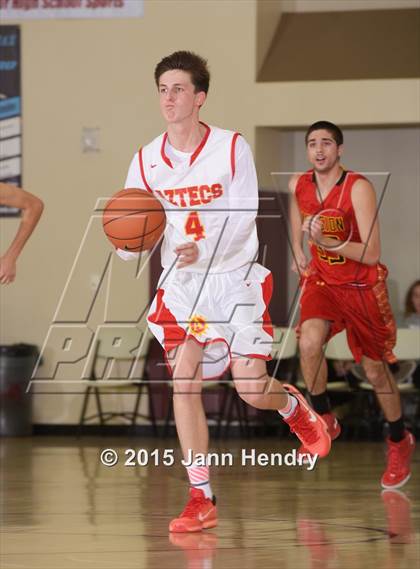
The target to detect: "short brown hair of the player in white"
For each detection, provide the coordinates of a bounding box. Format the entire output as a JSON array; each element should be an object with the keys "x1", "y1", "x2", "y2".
[{"x1": 155, "y1": 51, "x2": 210, "y2": 93}]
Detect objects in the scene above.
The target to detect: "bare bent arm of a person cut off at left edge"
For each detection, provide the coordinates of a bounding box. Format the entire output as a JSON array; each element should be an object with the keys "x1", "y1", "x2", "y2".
[{"x1": 0, "y1": 182, "x2": 44, "y2": 284}]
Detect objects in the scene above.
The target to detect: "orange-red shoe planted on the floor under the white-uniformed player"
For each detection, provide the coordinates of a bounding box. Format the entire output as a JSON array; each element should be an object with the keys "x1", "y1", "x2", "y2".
[{"x1": 169, "y1": 488, "x2": 217, "y2": 533}]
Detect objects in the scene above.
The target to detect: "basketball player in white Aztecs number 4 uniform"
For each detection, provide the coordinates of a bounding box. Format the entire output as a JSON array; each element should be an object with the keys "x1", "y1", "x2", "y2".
[{"x1": 117, "y1": 51, "x2": 331, "y2": 532}]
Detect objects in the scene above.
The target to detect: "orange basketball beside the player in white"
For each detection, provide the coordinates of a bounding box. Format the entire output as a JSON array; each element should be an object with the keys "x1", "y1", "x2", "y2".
[{"x1": 102, "y1": 188, "x2": 166, "y2": 252}]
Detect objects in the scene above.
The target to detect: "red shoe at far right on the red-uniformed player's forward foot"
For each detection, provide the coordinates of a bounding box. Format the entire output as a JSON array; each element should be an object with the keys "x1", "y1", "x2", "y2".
[{"x1": 381, "y1": 431, "x2": 416, "y2": 488}]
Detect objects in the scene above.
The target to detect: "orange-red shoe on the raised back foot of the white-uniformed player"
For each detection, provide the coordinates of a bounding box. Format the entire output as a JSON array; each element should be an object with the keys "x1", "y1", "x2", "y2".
[{"x1": 283, "y1": 383, "x2": 331, "y2": 457}]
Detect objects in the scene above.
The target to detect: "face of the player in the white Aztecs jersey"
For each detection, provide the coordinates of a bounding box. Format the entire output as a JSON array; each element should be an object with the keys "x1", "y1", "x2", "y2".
[{"x1": 159, "y1": 69, "x2": 206, "y2": 123}]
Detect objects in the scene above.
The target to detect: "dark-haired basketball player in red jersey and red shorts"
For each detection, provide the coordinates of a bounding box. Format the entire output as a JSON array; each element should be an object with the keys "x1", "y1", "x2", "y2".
[{"x1": 289, "y1": 121, "x2": 415, "y2": 488}]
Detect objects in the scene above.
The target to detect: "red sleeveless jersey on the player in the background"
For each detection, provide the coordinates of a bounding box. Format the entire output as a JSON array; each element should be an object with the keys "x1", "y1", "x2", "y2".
[{"x1": 295, "y1": 170, "x2": 378, "y2": 286}]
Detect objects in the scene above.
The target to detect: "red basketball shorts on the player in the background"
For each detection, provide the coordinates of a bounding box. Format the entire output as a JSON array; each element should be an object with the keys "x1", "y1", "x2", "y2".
[{"x1": 298, "y1": 276, "x2": 397, "y2": 363}]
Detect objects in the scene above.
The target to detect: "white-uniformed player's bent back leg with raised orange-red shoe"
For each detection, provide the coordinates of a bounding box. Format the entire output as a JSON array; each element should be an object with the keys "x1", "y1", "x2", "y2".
[{"x1": 231, "y1": 358, "x2": 331, "y2": 456}]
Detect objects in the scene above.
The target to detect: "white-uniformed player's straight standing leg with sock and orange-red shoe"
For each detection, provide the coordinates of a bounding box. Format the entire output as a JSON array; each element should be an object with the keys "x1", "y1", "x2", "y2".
[{"x1": 168, "y1": 340, "x2": 217, "y2": 532}]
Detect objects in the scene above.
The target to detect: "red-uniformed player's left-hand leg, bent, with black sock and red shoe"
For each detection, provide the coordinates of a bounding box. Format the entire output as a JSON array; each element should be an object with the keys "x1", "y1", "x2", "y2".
[{"x1": 299, "y1": 318, "x2": 341, "y2": 455}]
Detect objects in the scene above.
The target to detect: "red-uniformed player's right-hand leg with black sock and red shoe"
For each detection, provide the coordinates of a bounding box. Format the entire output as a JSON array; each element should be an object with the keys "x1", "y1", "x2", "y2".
[{"x1": 362, "y1": 356, "x2": 415, "y2": 488}]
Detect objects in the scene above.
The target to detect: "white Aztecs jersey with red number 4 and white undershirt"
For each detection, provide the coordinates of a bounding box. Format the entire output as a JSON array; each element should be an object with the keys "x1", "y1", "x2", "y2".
[{"x1": 125, "y1": 123, "x2": 258, "y2": 273}]
